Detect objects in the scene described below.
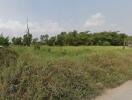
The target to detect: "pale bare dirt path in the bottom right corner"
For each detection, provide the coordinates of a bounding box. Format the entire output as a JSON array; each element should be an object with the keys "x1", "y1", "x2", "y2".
[{"x1": 95, "y1": 81, "x2": 132, "y2": 100}]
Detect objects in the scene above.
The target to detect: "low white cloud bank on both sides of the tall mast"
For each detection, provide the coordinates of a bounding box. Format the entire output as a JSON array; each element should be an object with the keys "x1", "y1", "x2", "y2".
[{"x1": 0, "y1": 19, "x2": 64, "y2": 36}]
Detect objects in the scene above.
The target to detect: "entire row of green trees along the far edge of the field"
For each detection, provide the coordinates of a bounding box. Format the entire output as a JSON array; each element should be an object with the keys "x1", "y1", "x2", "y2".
[{"x1": 0, "y1": 31, "x2": 130, "y2": 46}]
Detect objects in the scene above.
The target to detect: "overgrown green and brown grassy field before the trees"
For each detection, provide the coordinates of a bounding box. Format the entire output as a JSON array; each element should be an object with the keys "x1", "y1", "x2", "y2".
[{"x1": 0, "y1": 46, "x2": 132, "y2": 100}]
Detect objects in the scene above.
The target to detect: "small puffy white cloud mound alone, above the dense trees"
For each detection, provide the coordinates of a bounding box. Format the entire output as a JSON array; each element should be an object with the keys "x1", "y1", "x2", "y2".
[{"x1": 84, "y1": 13, "x2": 105, "y2": 28}]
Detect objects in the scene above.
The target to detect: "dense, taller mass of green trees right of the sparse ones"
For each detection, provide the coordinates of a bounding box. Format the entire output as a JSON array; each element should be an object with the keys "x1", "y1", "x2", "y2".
[{"x1": 44, "y1": 31, "x2": 128, "y2": 46}]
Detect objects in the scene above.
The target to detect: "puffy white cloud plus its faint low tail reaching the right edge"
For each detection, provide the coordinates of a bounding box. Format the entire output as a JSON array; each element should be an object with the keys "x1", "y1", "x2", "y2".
[{"x1": 83, "y1": 13, "x2": 131, "y2": 33}]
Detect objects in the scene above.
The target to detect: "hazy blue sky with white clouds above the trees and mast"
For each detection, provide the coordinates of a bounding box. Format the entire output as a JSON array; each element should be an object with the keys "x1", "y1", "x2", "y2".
[{"x1": 0, "y1": 0, "x2": 132, "y2": 36}]
